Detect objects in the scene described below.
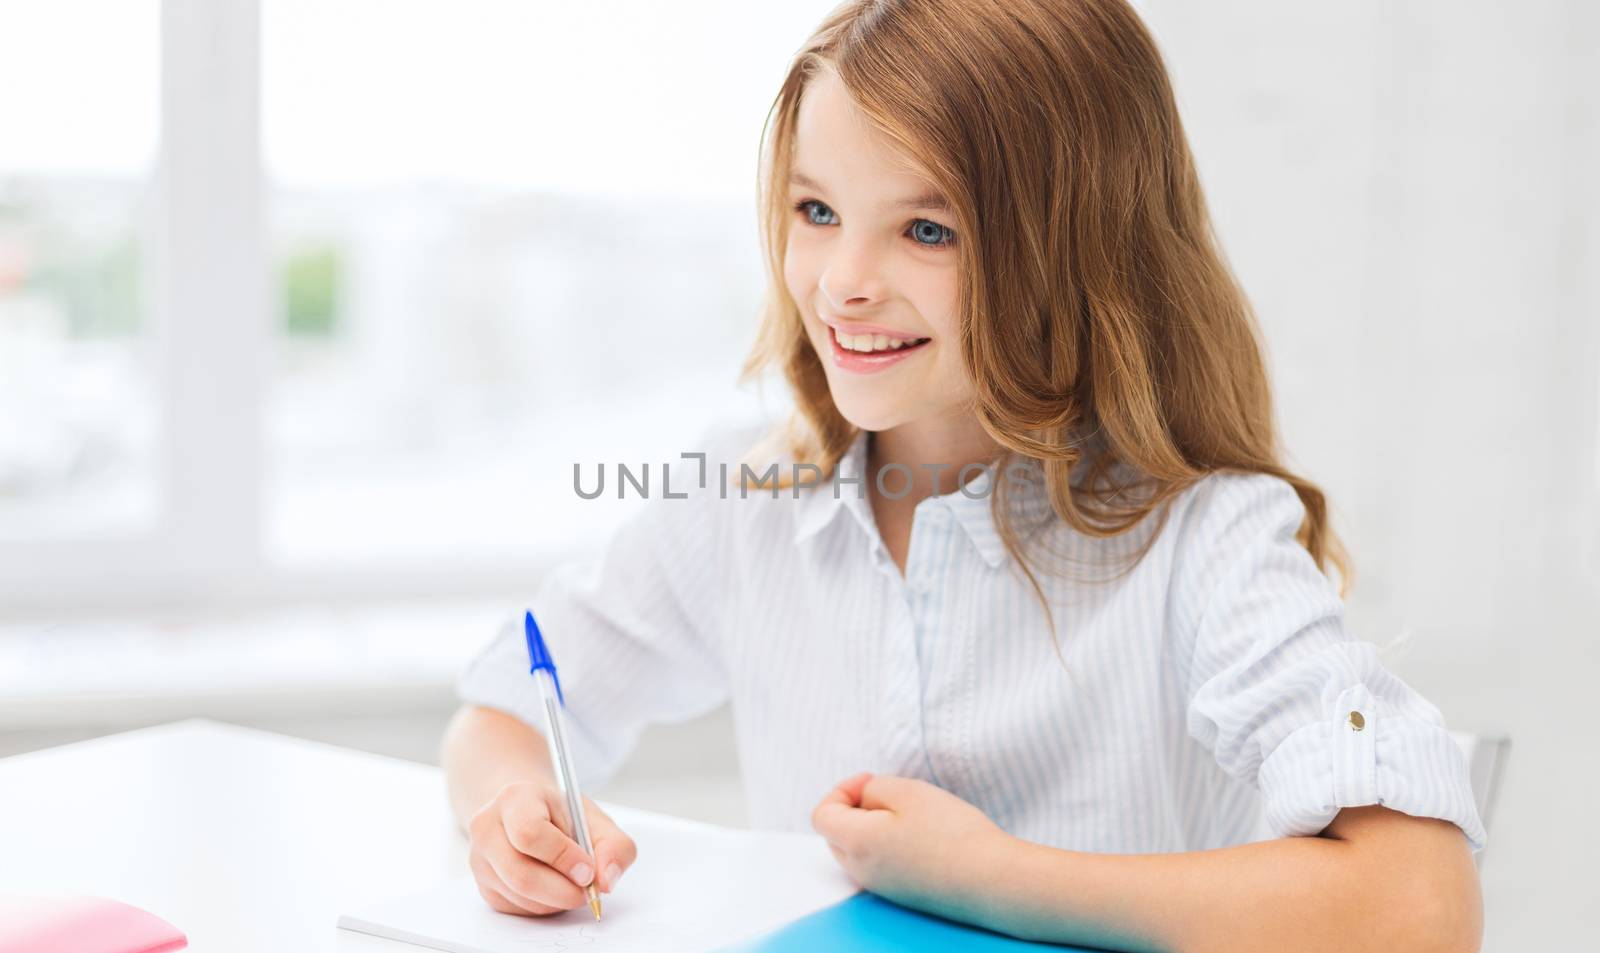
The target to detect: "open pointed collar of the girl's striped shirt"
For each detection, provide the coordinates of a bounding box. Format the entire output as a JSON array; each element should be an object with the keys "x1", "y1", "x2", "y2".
[{"x1": 794, "y1": 430, "x2": 1053, "y2": 569}]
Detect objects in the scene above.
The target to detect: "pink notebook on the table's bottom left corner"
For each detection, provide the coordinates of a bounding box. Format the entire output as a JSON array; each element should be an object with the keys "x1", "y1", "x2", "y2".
[{"x1": 0, "y1": 897, "x2": 189, "y2": 953}]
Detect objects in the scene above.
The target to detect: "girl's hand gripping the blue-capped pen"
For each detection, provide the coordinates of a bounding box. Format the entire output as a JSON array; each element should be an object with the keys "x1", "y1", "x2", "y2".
[{"x1": 467, "y1": 780, "x2": 638, "y2": 916}]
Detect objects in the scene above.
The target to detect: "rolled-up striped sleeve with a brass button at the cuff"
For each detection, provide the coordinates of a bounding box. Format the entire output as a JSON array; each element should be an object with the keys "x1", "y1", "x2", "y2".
[{"x1": 1173, "y1": 473, "x2": 1486, "y2": 851}]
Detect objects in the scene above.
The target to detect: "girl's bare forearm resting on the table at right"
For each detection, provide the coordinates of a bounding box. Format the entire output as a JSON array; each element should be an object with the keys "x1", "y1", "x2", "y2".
[{"x1": 984, "y1": 809, "x2": 1482, "y2": 953}]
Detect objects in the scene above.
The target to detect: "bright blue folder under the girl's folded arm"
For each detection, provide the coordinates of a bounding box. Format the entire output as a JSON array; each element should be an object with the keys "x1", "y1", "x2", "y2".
[{"x1": 723, "y1": 892, "x2": 1113, "y2": 953}]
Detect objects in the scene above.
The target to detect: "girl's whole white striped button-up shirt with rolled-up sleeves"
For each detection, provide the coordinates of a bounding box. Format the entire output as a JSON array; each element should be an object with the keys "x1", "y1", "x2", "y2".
[{"x1": 459, "y1": 432, "x2": 1485, "y2": 854}]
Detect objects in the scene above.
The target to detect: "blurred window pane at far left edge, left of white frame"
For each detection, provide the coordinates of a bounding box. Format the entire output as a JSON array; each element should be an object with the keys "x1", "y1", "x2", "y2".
[{"x1": 0, "y1": 0, "x2": 160, "y2": 542}]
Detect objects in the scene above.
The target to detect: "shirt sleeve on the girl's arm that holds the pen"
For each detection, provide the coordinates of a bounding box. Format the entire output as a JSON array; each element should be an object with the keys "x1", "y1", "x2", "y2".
[{"x1": 458, "y1": 454, "x2": 728, "y2": 784}]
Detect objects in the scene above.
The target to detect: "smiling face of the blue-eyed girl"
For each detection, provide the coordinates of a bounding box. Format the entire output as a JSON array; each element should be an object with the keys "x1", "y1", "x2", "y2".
[{"x1": 784, "y1": 70, "x2": 971, "y2": 430}]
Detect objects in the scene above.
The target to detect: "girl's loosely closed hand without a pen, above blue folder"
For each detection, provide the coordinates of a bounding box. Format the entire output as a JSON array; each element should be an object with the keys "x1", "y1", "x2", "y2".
[{"x1": 811, "y1": 774, "x2": 1014, "y2": 923}]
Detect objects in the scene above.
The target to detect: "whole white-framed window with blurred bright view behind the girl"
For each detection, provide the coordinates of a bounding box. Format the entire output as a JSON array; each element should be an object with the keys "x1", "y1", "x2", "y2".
[{"x1": 0, "y1": 0, "x2": 830, "y2": 608}]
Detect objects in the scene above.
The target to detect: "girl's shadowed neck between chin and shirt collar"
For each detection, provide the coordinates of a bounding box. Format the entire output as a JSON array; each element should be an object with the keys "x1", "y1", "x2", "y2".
[{"x1": 867, "y1": 416, "x2": 1005, "y2": 505}]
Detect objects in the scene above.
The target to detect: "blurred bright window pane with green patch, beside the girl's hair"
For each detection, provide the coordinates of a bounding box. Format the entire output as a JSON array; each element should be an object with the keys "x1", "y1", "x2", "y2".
[{"x1": 262, "y1": 0, "x2": 830, "y2": 566}]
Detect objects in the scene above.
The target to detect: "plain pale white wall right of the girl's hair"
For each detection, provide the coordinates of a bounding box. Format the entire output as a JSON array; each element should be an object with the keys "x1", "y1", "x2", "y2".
[{"x1": 1146, "y1": 0, "x2": 1600, "y2": 950}]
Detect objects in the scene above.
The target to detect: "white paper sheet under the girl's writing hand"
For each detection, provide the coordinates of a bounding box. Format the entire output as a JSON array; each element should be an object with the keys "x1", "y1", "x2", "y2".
[{"x1": 339, "y1": 804, "x2": 856, "y2": 953}]
